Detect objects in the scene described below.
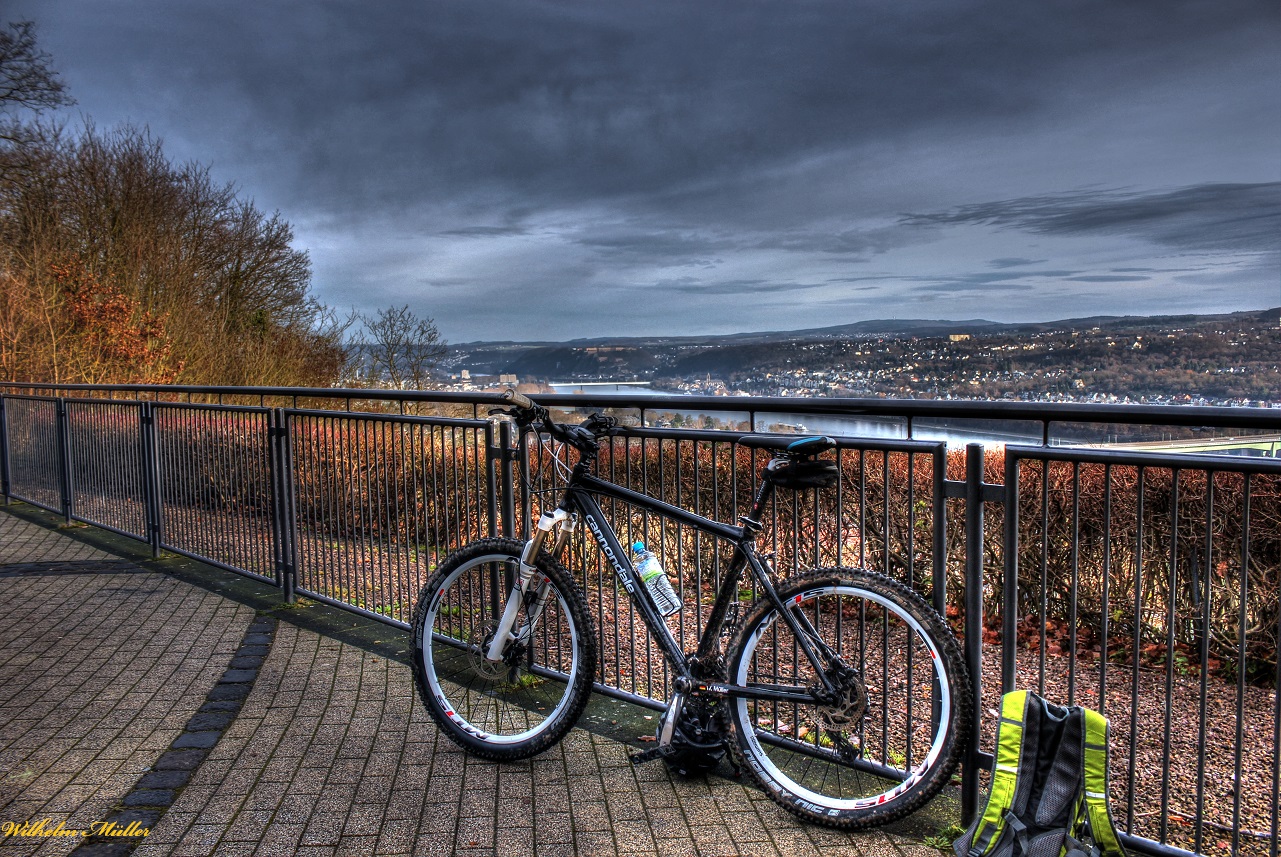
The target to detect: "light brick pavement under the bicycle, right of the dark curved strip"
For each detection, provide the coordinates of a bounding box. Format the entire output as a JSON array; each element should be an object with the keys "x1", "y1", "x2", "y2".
[{"x1": 135, "y1": 623, "x2": 936, "y2": 857}]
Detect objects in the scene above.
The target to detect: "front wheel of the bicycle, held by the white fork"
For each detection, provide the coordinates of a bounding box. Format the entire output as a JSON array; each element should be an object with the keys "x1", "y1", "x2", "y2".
[{"x1": 414, "y1": 539, "x2": 596, "y2": 760}]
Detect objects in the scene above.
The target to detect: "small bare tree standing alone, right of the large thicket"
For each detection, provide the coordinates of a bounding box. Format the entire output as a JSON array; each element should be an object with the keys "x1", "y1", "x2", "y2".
[{"x1": 355, "y1": 305, "x2": 447, "y2": 389}]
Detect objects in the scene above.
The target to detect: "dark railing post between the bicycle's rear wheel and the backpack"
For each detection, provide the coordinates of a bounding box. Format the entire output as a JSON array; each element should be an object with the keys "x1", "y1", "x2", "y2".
[{"x1": 961, "y1": 443, "x2": 984, "y2": 826}]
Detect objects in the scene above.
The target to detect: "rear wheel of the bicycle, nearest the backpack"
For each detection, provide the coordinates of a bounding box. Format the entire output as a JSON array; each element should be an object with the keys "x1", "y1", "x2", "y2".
[{"x1": 729, "y1": 569, "x2": 971, "y2": 829}]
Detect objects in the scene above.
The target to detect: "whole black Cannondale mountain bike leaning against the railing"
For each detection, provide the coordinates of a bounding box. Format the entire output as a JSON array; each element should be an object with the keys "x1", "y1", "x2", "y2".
[{"x1": 412, "y1": 391, "x2": 971, "y2": 829}]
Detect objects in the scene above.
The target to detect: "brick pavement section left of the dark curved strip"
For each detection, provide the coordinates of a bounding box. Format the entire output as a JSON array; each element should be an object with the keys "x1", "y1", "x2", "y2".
[{"x1": 0, "y1": 512, "x2": 252, "y2": 856}]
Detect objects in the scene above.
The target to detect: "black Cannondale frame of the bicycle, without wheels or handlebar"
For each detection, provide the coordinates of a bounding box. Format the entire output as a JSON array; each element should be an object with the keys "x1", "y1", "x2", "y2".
[{"x1": 561, "y1": 464, "x2": 836, "y2": 702}]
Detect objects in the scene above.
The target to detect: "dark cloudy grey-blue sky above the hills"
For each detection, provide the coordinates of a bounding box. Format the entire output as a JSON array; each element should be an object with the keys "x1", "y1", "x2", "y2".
[{"x1": 12, "y1": 0, "x2": 1281, "y2": 342}]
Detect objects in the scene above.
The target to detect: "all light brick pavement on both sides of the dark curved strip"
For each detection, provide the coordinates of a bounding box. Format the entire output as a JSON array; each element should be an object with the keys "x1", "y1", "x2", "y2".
[{"x1": 0, "y1": 510, "x2": 939, "y2": 857}]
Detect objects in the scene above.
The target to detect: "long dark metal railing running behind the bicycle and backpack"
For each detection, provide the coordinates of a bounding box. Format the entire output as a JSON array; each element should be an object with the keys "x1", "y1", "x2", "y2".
[{"x1": 0, "y1": 384, "x2": 1281, "y2": 856}]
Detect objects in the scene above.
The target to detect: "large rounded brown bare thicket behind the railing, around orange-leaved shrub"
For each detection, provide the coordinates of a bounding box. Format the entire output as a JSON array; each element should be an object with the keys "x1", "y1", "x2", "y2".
[{"x1": 0, "y1": 126, "x2": 346, "y2": 387}]
